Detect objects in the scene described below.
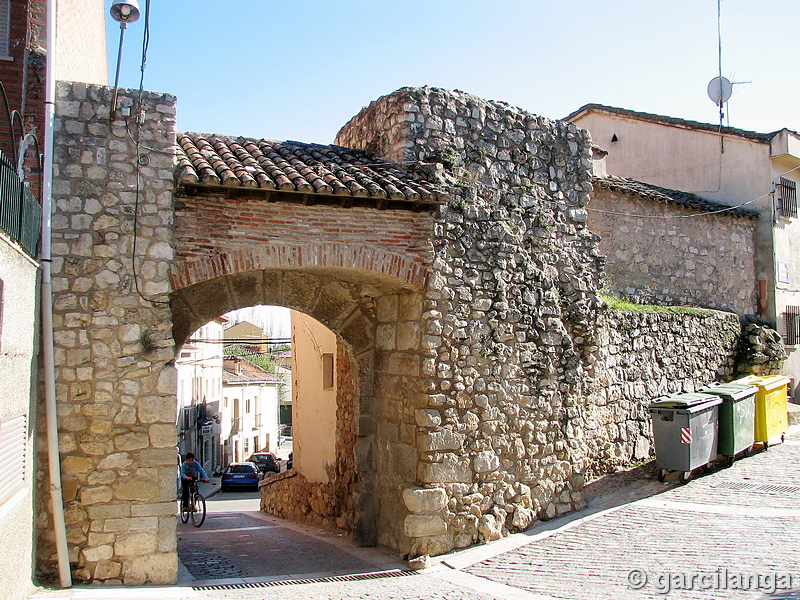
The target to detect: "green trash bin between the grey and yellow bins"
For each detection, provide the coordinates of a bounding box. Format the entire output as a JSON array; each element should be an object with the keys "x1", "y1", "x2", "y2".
[{"x1": 697, "y1": 383, "x2": 758, "y2": 466}]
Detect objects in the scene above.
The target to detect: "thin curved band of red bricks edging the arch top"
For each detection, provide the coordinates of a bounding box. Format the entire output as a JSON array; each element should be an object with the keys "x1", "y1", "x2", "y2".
[{"x1": 170, "y1": 242, "x2": 429, "y2": 290}]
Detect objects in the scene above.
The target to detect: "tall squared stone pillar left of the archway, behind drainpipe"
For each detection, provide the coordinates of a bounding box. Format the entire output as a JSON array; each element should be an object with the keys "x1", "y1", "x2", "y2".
[{"x1": 37, "y1": 83, "x2": 177, "y2": 584}]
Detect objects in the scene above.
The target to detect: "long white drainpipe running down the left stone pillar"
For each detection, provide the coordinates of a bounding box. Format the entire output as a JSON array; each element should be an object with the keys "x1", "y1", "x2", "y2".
[{"x1": 40, "y1": 0, "x2": 72, "y2": 588}]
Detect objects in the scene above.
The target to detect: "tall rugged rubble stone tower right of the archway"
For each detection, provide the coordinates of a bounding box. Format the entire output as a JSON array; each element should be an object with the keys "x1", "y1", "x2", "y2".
[{"x1": 337, "y1": 88, "x2": 601, "y2": 555}]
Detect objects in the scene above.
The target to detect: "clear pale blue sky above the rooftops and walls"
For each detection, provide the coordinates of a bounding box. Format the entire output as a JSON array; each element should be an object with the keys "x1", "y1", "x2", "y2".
[{"x1": 106, "y1": 0, "x2": 800, "y2": 143}]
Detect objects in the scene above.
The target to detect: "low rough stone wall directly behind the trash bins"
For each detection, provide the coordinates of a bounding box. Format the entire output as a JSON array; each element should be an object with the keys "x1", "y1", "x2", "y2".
[{"x1": 584, "y1": 309, "x2": 741, "y2": 478}]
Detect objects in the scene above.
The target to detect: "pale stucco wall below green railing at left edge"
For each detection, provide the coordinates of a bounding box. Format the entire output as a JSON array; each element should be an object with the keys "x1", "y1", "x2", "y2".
[{"x1": 0, "y1": 233, "x2": 39, "y2": 600}]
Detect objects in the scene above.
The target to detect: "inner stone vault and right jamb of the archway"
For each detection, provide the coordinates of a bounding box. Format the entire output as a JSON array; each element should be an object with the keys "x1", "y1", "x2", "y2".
[{"x1": 171, "y1": 266, "x2": 424, "y2": 547}]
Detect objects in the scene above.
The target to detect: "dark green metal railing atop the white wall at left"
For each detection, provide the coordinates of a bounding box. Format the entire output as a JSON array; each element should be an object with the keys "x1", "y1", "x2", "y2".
[{"x1": 0, "y1": 152, "x2": 42, "y2": 256}]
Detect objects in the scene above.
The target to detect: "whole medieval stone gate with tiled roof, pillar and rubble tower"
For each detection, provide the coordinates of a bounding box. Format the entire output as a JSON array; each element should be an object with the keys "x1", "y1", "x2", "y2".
[{"x1": 37, "y1": 84, "x2": 752, "y2": 584}]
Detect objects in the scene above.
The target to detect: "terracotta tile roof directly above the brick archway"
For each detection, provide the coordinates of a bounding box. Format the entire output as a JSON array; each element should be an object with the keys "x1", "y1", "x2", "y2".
[{"x1": 176, "y1": 133, "x2": 448, "y2": 208}]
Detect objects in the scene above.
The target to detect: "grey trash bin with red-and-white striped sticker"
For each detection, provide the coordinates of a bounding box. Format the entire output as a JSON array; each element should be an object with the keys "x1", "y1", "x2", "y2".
[{"x1": 649, "y1": 392, "x2": 722, "y2": 483}]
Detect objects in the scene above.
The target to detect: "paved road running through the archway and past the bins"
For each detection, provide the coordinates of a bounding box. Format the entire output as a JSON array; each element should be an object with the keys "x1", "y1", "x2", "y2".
[{"x1": 26, "y1": 431, "x2": 800, "y2": 600}]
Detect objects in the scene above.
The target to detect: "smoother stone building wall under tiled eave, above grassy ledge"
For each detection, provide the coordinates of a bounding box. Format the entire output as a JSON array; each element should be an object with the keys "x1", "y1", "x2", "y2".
[{"x1": 588, "y1": 186, "x2": 758, "y2": 315}]
